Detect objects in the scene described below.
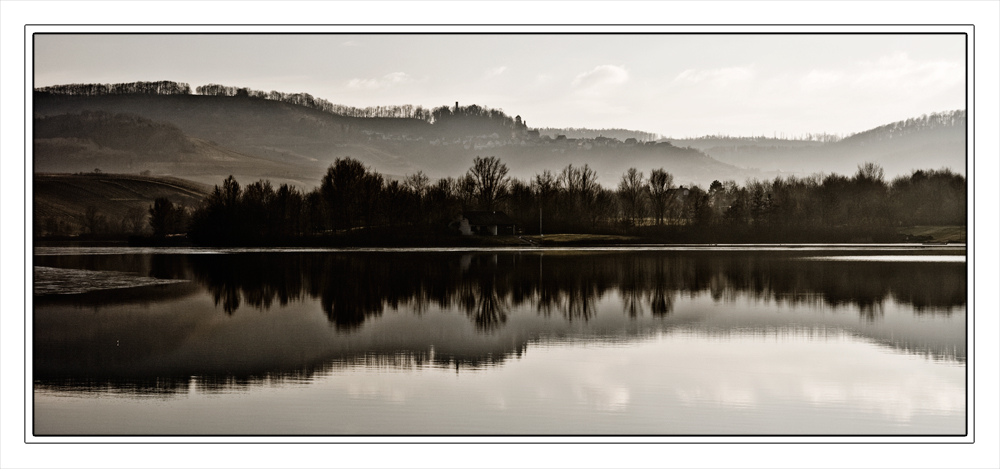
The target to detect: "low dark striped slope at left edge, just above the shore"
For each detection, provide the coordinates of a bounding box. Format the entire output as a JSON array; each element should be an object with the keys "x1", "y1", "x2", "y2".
[{"x1": 32, "y1": 173, "x2": 212, "y2": 235}]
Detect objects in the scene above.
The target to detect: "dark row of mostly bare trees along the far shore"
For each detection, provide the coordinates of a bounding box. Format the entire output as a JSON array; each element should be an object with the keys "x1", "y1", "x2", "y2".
[{"x1": 182, "y1": 157, "x2": 966, "y2": 245}]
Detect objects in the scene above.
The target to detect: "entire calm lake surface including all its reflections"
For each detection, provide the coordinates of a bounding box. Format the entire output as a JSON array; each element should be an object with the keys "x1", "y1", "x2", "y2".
[{"x1": 32, "y1": 246, "x2": 967, "y2": 436}]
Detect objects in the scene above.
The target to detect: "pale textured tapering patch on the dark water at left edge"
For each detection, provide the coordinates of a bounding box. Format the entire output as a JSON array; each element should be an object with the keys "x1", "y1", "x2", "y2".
[{"x1": 34, "y1": 266, "x2": 187, "y2": 295}]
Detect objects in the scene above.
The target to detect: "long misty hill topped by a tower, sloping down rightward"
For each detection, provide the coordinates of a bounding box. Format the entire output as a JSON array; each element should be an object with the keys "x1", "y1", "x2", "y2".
[{"x1": 34, "y1": 93, "x2": 766, "y2": 189}]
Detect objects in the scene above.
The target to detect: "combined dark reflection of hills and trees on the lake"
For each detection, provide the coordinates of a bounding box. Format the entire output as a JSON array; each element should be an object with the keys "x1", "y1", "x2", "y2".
[{"x1": 33, "y1": 251, "x2": 966, "y2": 394}]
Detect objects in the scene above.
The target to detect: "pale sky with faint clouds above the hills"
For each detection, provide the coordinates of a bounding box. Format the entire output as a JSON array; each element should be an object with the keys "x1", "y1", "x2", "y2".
[{"x1": 35, "y1": 34, "x2": 966, "y2": 137}]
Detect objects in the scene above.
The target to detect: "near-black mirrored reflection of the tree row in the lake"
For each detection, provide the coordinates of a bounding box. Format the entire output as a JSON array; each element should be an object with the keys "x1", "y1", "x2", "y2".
[{"x1": 184, "y1": 252, "x2": 966, "y2": 331}]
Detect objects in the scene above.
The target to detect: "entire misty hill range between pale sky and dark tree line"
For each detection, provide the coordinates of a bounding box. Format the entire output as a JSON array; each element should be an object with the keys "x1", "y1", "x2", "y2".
[{"x1": 33, "y1": 82, "x2": 965, "y2": 189}]
